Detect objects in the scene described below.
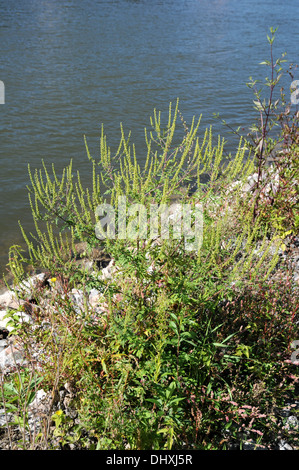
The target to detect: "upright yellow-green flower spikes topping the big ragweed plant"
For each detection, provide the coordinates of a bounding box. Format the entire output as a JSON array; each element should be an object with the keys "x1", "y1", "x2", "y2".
[{"x1": 9, "y1": 97, "x2": 282, "y2": 288}]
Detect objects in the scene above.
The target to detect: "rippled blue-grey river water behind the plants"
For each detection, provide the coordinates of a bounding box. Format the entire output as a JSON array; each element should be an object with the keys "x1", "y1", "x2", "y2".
[{"x1": 0, "y1": 0, "x2": 299, "y2": 276}]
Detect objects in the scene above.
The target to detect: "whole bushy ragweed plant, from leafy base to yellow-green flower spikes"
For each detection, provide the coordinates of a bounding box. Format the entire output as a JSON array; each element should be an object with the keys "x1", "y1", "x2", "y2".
[{"x1": 3, "y1": 97, "x2": 296, "y2": 449}]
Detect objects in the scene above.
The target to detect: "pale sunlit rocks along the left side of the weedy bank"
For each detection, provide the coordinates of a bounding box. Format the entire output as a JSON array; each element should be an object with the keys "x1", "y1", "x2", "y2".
[{"x1": 0, "y1": 248, "x2": 114, "y2": 450}]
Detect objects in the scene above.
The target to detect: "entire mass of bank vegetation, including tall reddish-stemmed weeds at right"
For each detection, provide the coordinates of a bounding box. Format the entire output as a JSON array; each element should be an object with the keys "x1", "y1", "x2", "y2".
[{"x1": 2, "y1": 27, "x2": 298, "y2": 450}]
